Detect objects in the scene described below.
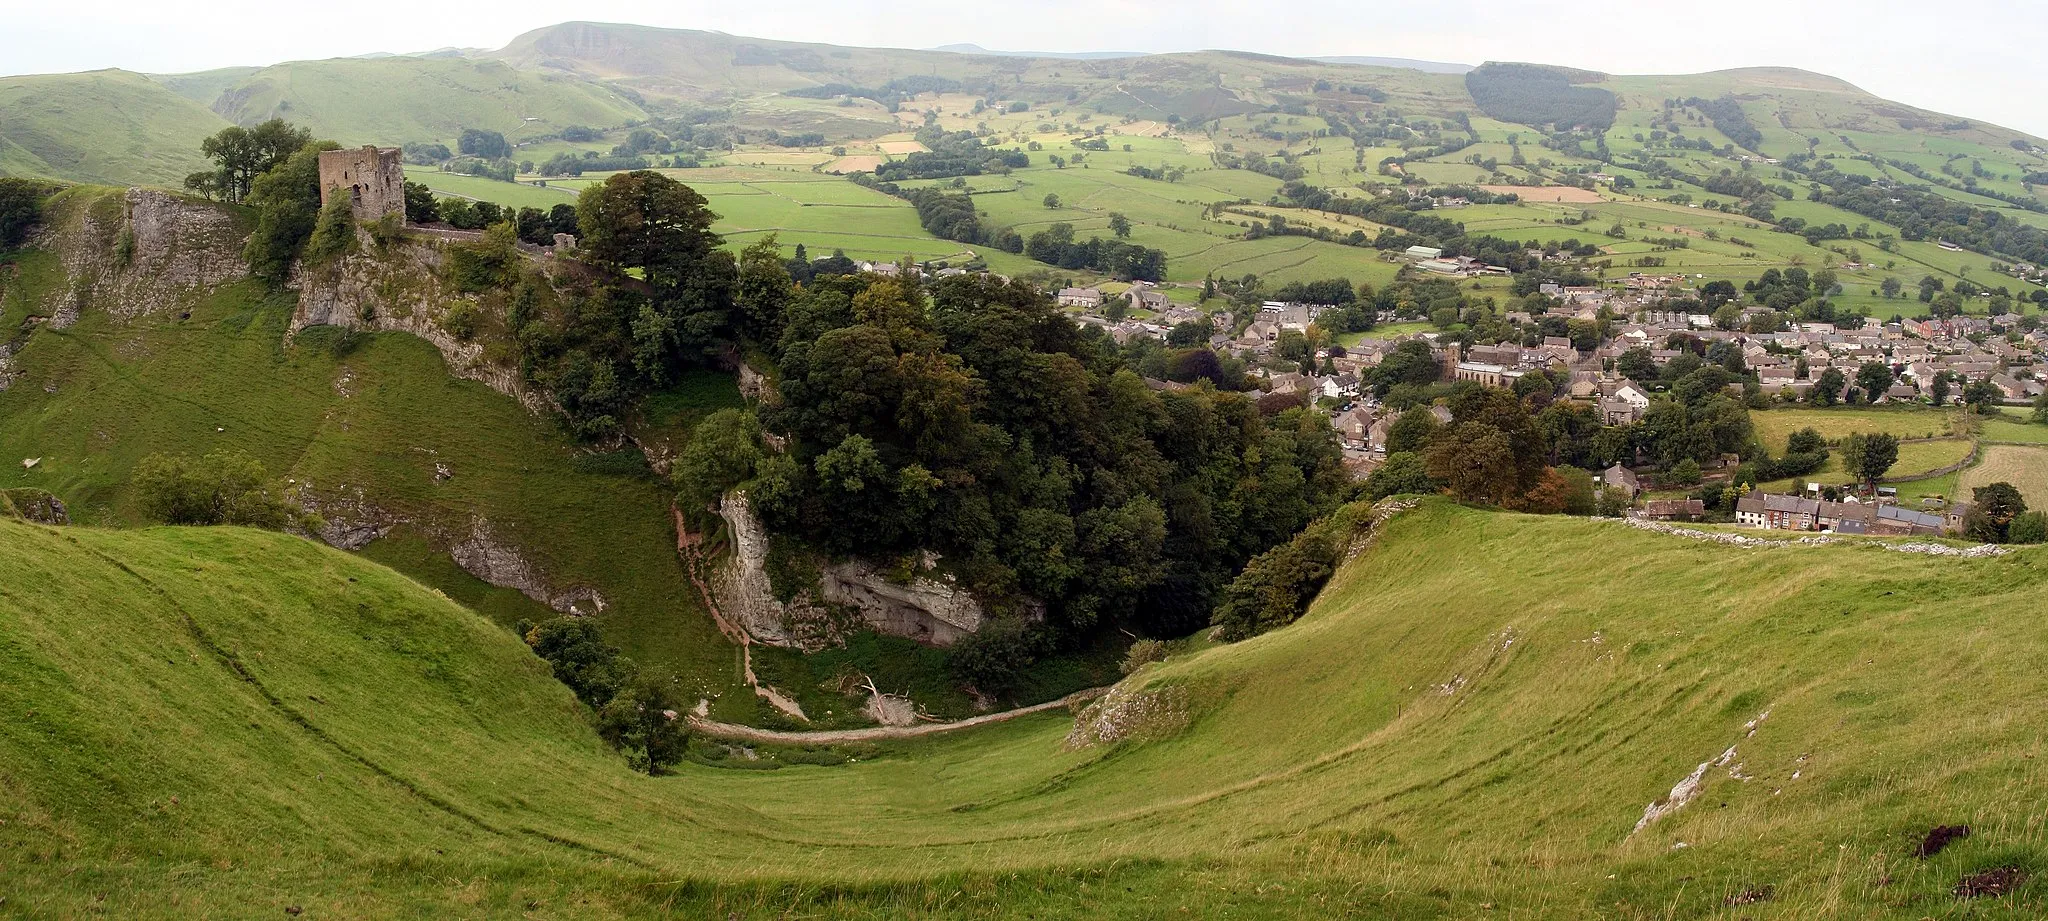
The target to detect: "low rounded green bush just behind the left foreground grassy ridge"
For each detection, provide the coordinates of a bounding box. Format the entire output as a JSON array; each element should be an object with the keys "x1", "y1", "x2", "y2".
[{"x1": 133, "y1": 450, "x2": 307, "y2": 530}]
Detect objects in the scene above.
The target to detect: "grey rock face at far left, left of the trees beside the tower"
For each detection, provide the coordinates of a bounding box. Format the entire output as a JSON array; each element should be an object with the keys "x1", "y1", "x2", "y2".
[{"x1": 37, "y1": 188, "x2": 248, "y2": 330}]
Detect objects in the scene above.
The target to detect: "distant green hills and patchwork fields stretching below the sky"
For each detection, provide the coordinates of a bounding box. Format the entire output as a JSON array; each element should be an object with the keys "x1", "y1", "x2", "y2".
[{"x1": 0, "y1": 23, "x2": 2048, "y2": 309}]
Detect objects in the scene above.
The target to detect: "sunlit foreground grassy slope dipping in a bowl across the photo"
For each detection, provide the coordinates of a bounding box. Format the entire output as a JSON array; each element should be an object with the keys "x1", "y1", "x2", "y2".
[{"x1": 0, "y1": 501, "x2": 2048, "y2": 919}]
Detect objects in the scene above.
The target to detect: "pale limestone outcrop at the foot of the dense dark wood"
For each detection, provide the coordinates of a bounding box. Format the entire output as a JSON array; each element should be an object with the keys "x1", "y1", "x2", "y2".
[{"x1": 711, "y1": 493, "x2": 1024, "y2": 649}]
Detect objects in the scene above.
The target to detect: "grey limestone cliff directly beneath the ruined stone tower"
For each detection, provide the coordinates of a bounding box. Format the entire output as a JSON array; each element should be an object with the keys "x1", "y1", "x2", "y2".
[{"x1": 289, "y1": 231, "x2": 547, "y2": 411}]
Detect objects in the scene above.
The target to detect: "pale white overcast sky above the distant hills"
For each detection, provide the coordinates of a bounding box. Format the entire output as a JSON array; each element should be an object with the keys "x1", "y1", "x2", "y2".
[{"x1": 12, "y1": 0, "x2": 2048, "y2": 137}]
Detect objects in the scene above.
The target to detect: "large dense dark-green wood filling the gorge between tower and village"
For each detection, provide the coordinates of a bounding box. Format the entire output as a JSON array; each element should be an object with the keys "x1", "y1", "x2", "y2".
[{"x1": 676, "y1": 262, "x2": 1346, "y2": 634}]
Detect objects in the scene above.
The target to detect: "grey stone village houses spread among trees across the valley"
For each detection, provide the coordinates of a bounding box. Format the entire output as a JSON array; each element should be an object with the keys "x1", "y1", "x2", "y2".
[{"x1": 1057, "y1": 258, "x2": 2048, "y2": 536}]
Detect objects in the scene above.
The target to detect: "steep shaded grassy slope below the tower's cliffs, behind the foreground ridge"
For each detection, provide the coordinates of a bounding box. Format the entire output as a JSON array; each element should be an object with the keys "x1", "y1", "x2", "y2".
[{"x1": 0, "y1": 190, "x2": 754, "y2": 718}]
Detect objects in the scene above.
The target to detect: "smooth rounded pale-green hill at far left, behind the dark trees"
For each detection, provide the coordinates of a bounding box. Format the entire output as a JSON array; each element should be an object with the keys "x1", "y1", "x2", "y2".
[{"x1": 0, "y1": 70, "x2": 227, "y2": 186}]
